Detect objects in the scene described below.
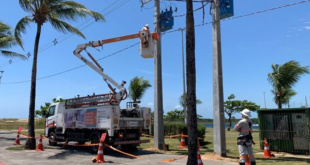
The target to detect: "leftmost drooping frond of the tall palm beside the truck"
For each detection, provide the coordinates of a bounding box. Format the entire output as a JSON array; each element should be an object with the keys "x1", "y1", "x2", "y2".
[{"x1": 14, "y1": 16, "x2": 32, "y2": 49}]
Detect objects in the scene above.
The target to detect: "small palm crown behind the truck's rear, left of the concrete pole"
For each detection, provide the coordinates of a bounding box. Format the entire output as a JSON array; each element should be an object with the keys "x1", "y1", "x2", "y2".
[{"x1": 129, "y1": 76, "x2": 152, "y2": 106}]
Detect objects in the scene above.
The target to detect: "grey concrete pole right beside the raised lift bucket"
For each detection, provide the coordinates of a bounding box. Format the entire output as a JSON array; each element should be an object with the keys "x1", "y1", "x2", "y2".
[{"x1": 154, "y1": 0, "x2": 164, "y2": 150}]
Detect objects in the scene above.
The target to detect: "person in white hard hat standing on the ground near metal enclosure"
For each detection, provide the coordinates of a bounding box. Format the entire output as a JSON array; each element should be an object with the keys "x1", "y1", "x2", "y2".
[{"x1": 235, "y1": 109, "x2": 256, "y2": 165}]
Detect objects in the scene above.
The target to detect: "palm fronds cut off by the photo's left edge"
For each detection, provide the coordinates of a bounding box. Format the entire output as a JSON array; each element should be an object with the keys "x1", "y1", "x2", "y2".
[{"x1": 0, "y1": 22, "x2": 28, "y2": 60}]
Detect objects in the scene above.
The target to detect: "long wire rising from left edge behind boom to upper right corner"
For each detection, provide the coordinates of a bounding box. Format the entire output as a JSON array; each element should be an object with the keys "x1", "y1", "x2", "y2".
[{"x1": 2, "y1": 0, "x2": 310, "y2": 84}]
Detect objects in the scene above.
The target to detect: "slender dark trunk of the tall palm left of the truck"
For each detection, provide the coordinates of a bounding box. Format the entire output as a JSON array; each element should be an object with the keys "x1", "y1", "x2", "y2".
[{"x1": 25, "y1": 23, "x2": 41, "y2": 150}]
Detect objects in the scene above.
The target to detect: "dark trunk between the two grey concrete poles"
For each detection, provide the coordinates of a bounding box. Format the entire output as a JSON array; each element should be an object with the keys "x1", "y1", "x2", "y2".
[{"x1": 186, "y1": 0, "x2": 197, "y2": 165}]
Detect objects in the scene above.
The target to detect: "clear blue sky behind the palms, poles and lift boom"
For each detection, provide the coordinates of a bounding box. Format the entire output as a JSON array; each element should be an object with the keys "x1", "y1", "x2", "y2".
[{"x1": 0, "y1": 0, "x2": 310, "y2": 118}]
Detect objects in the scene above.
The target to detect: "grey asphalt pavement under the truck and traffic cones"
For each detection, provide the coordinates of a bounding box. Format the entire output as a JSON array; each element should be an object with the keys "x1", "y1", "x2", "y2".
[{"x1": 0, "y1": 131, "x2": 237, "y2": 165}]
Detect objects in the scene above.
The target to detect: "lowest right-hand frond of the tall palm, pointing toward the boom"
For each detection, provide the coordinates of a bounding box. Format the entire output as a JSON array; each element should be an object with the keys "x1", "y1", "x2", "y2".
[{"x1": 48, "y1": 17, "x2": 86, "y2": 38}]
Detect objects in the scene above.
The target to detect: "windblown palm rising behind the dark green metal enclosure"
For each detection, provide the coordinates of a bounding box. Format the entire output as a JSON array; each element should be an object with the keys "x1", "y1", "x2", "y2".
[{"x1": 268, "y1": 60, "x2": 309, "y2": 109}]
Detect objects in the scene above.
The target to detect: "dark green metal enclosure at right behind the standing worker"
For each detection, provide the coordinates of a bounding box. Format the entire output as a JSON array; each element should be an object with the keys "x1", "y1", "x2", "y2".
[{"x1": 258, "y1": 109, "x2": 310, "y2": 154}]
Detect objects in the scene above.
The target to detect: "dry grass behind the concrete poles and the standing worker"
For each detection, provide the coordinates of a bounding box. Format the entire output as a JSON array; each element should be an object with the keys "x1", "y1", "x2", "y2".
[{"x1": 140, "y1": 128, "x2": 310, "y2": 165}]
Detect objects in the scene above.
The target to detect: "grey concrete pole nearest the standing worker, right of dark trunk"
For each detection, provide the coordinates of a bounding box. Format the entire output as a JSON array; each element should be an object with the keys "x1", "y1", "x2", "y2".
[{"x1": 212, "y1": 0, "x2": 226, "y2": 156}]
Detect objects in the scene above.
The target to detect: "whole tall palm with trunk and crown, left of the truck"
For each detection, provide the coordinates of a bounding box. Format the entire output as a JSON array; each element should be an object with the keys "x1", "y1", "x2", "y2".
[{"x1": 14, "y1": 0, "x2": 104, "y2": 149}]
